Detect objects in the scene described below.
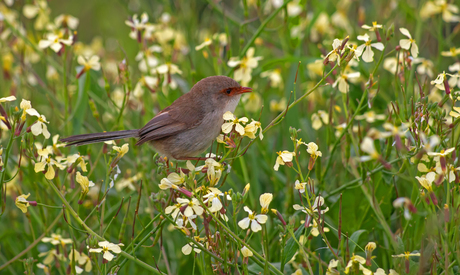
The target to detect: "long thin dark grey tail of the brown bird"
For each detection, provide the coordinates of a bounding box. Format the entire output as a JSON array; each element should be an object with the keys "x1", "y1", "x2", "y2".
[{"x1": 60, "y1": 130, "x2": 139, "y2": 146}]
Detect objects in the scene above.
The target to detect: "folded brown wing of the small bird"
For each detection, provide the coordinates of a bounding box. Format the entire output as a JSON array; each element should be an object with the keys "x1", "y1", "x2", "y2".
[{"x1": 136, "y1": 102, "x2": 204, "y2": 145}]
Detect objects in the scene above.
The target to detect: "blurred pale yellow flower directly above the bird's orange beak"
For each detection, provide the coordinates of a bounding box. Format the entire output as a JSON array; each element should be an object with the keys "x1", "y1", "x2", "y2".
[{"x1": 227, "y1": 47, "x2": 262, "y2": 85}]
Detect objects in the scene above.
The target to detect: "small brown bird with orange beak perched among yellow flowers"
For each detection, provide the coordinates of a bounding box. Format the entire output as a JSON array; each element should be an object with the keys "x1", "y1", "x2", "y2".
[{"x1": 61, "y1": 76, "x2": 252, "y2": 160}]
